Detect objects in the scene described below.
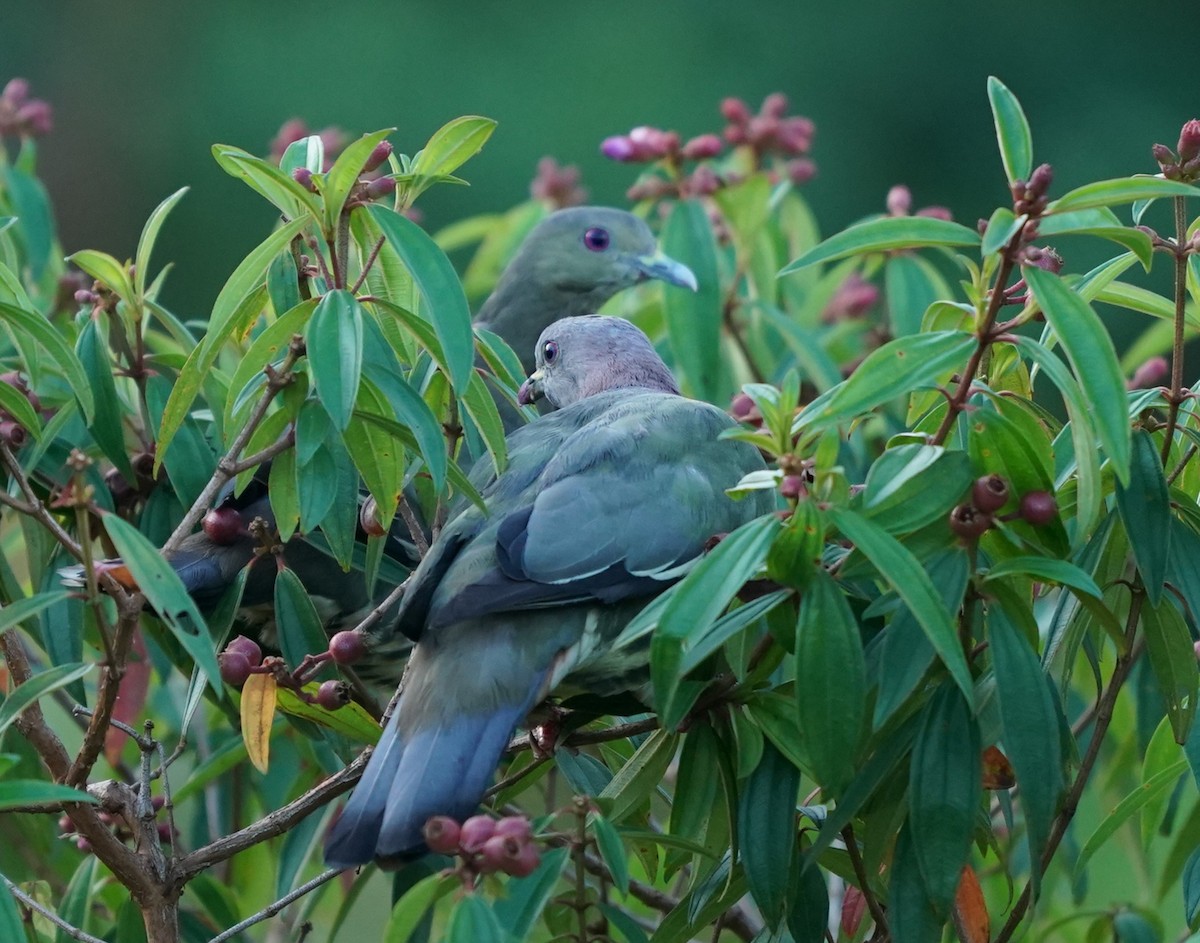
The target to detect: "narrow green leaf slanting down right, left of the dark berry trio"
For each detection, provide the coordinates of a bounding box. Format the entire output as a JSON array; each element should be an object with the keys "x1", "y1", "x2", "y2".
[{"x1": 829, "y1": 507, "x2": 974, "y2": 709}]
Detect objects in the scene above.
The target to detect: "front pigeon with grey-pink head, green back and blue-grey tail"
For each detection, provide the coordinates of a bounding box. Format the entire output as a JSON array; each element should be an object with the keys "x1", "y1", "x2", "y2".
[{"x1": 325, "y1": 316, "x2": 774, "y2": 867}]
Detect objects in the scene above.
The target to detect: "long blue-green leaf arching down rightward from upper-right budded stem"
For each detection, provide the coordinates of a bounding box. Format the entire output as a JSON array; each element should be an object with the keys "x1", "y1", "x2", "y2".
[{"x1": 1022, "y1": 265, "x2": 1130, "y2": 485}]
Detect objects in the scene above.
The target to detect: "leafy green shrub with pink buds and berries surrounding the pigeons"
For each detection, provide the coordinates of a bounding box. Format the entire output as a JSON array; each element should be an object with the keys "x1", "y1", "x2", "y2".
[{"x1": 0, "y1": 79, "x2": 1200, "y2": 943}]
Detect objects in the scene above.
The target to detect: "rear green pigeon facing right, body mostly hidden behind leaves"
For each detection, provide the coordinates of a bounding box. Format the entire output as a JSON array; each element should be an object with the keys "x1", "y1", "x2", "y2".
[{"x1": 62, "y1": 206, "x2": 696, "y2": 657}]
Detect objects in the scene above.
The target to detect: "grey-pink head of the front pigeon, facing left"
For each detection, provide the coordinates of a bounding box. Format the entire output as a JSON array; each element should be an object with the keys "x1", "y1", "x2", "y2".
[{"x1": 517, "y1": 314, "x2": 679, "y2": 409}]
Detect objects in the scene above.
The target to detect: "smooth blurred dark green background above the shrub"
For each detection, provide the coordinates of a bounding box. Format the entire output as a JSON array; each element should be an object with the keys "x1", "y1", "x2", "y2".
[{"x1": 0, "y1": 0, "x2": 1200, "y2": 318}]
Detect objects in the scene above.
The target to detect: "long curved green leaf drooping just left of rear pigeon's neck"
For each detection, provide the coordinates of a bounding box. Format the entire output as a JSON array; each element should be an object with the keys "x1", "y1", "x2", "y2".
[{"x1": 367, "y1": 205, "x2": 475, "y2": 394}]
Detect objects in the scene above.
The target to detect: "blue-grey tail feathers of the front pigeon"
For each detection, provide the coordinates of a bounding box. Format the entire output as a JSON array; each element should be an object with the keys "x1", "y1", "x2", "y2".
[{"x1": 325, "y1": 691, "x2": 533, "y2": 867}]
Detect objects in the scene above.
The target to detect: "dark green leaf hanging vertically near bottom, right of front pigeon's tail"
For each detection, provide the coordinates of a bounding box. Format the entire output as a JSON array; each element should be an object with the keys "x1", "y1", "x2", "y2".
[{"x1": 738, "y1": 743, "x2": 800, "y2": 927}]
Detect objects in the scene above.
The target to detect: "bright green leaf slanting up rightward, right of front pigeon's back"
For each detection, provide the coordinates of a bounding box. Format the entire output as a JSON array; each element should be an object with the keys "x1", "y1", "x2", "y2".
[{"x1": 796, "y1": 331, "x2": 977, "y2": 431}]
